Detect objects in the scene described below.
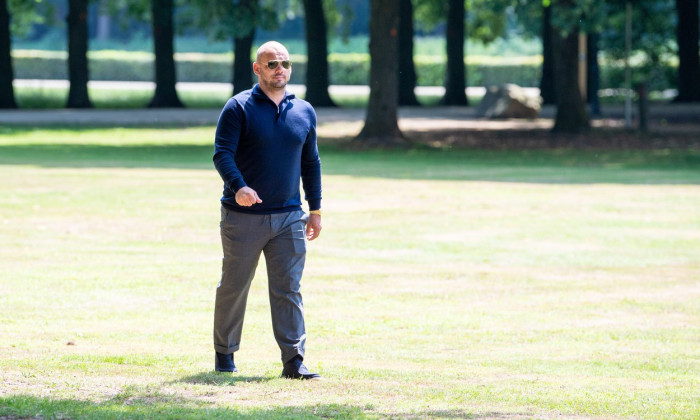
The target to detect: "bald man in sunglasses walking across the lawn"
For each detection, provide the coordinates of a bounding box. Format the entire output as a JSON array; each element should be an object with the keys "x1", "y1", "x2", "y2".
[{"x1": 214, "y1": 42, "x2": 321, "y2": 379}]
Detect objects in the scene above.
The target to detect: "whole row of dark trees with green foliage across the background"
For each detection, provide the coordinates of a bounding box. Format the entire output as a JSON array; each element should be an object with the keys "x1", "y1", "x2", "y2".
[{"x1": 0, "y1": 0, "x2": 700, "y2": 141}]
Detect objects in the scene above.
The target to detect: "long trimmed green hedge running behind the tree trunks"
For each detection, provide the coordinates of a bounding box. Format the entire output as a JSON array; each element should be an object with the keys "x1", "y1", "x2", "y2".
[{"x1": 13, "y1": 50, "x2": 676, "y2": 90}]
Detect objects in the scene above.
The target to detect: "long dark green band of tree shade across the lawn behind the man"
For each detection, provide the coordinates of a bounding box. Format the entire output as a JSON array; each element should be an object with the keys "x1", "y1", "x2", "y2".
[{"x1": 0, "y1": 139, "x2": 700, "y2": 185}]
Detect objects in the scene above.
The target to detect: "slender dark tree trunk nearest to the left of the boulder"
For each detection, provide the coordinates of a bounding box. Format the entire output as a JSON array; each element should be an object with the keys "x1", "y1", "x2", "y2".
[{"x1": 441, "y1": 0, "x2": 469, "y2": 105}]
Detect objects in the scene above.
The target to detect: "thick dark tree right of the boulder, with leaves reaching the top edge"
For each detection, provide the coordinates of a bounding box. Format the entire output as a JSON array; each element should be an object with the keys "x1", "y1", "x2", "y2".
[{"x1": 552, "y1": 0, "x2": 590, "y2": 133}]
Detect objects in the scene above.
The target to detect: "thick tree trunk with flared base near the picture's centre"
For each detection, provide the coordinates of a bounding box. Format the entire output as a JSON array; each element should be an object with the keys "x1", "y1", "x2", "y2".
[{"x1": 356, "y1": 0, "x2": 406, "y2": 147}]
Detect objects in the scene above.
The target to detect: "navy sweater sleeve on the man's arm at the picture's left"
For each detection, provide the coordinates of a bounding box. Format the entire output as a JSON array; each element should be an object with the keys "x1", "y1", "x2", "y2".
[{"x1": 213, "y1": 99, "x2": 246, "y2": 193}]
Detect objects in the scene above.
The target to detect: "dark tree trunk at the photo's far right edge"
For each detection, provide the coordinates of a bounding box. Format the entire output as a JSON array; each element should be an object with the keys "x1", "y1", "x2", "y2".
[{"x1": 675, "y1": 0, "x2": 700, "y2": 102}]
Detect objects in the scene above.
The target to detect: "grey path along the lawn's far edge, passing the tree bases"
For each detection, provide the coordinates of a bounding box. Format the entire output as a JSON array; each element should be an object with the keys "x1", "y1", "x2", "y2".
[{"x1": 0, "y1": 104, "x2": 700, "y2": 137}]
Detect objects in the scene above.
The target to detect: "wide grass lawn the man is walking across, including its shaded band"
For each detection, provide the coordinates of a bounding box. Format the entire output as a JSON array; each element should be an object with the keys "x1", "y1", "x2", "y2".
[{"x1": 0, "y1": 127, "x2": 700, "y2": 420}]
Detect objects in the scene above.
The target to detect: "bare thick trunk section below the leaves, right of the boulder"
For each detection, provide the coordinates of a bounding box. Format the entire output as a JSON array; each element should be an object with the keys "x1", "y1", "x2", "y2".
[{"x1": 552, "y1": 28, "x2": 590, "y2": 133}]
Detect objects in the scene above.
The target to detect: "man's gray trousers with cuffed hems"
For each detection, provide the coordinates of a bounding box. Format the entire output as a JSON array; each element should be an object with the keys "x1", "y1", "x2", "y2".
[{"x1": 214, "y1": 207, "x2": 307, "y2": 362}]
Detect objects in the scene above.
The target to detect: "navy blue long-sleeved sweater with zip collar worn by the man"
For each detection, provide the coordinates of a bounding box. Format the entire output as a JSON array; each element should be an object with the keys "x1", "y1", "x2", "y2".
[{"x1": 214, "y1": 84, "x2": 321, "y2": 214}]
